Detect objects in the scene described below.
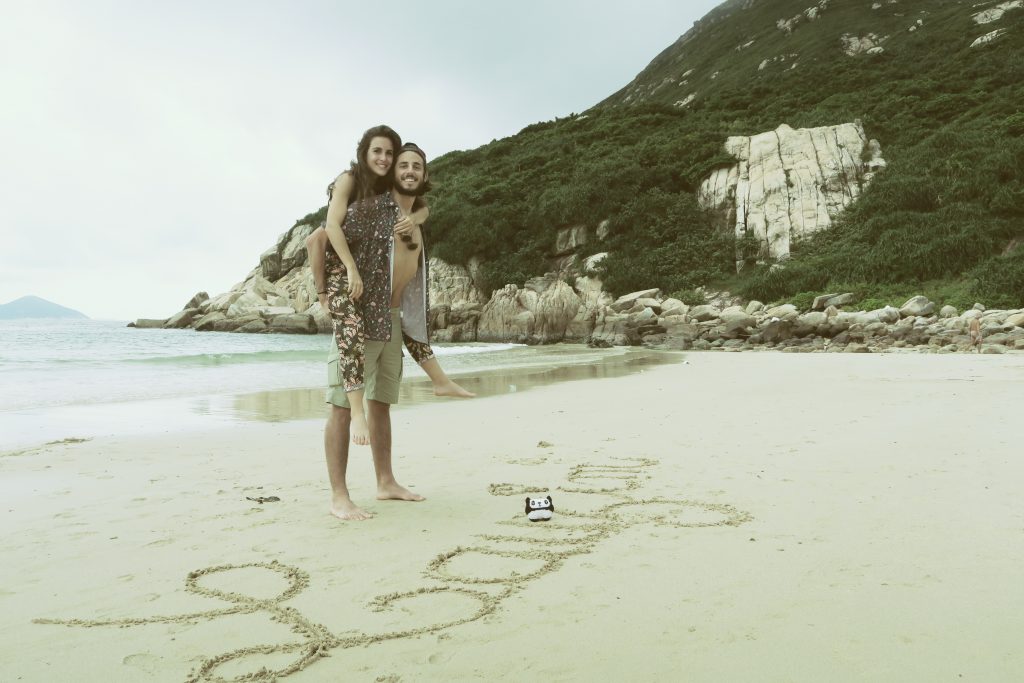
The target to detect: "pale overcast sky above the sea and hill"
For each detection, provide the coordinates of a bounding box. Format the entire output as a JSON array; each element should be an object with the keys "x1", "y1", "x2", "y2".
[{"x1": 0, "y1": 0, "x2": 719, "y2": 319}]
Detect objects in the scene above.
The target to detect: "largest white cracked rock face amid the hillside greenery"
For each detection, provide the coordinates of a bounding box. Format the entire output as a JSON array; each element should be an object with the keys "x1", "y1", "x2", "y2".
[{"x1": 697, "y1": 121, "x2": 885, "y2": 266}]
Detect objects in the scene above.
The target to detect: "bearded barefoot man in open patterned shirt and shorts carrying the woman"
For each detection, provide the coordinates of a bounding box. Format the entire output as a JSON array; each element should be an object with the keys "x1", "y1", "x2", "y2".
[{"x1": 324, "y1": 142, "x2": 429, "y2": 520}]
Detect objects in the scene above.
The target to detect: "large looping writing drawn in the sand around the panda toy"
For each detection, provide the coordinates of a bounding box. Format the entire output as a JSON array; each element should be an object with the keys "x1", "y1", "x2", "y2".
[{"x1": 35, "y1": 458, "x2": 751, "y2": 683}]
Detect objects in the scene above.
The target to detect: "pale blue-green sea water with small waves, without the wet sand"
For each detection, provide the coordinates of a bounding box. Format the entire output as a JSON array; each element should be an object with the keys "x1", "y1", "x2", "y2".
[{"x1": 0, "y1": 321, "x2": 517, "y2": 411}]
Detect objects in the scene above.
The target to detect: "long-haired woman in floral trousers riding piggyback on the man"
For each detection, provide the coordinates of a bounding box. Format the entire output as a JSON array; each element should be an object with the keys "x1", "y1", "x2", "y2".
[{"x1": 306, "y1": 126, "x2": 474, "y2": 445}]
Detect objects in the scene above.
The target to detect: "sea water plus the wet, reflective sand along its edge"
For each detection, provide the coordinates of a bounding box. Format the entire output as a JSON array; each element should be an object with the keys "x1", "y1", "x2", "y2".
[{"x1": 0, "y1": 321, "x2": 676, "y2": 455}]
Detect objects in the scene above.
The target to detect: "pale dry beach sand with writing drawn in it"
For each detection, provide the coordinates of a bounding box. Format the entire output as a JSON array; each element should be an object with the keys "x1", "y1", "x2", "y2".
[{"x1": 0, "y1": 353, "x2": 1024, "y2": 682}]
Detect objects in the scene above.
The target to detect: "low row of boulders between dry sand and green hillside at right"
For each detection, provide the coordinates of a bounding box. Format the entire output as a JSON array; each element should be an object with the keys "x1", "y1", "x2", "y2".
[{"x1": 589, "y1": 290, "x2": 1024, "y2": 353}]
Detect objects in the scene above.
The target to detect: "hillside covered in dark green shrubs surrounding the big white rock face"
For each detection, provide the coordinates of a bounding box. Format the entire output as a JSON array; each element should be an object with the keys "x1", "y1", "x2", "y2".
[{"x1": 299, "y1": 0, "x2": 1024, "y2": 306}]
